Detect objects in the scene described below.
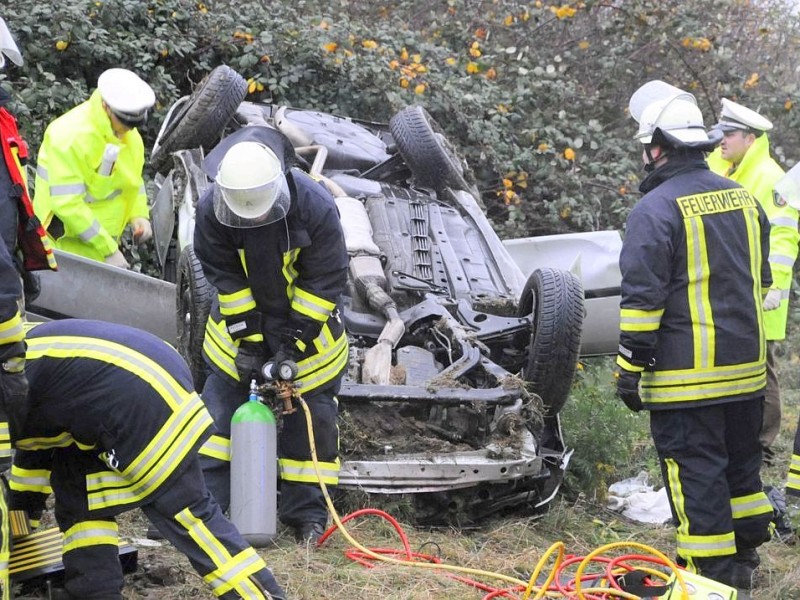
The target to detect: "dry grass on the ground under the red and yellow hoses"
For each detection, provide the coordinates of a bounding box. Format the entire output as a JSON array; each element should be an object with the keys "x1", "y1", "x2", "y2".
[{"x1": 109, "y1": 492, "x2": 800, "y2": 600}]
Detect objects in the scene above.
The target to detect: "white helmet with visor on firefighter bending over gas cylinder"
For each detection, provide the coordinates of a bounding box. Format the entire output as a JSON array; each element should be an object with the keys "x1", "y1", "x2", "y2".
[{"x1": 214, "y1": 142, "x2": 291, "y2": 228}]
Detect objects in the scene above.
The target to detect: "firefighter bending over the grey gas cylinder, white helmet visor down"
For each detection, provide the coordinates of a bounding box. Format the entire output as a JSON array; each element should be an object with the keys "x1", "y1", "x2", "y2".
[{"x1": 194, "y1": 126, "x2": 348, "y2": 543}]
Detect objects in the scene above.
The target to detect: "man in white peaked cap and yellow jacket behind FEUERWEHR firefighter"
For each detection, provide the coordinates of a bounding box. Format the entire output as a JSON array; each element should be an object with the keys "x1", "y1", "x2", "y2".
[{"x1": 708, "y1": 98, "x2": 800, "y2": 464}]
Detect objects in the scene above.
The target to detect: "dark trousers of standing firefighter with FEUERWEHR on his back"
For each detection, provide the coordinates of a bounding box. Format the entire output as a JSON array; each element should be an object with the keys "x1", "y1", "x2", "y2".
[{"x1": 650, "y1": 398, "x2": 772, "y2": 583}]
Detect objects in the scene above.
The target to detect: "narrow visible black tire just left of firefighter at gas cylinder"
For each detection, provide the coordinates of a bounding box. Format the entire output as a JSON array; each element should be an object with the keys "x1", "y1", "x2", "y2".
[{"x1": 175, "y1": 246, "x2": 216, "y2": 392}]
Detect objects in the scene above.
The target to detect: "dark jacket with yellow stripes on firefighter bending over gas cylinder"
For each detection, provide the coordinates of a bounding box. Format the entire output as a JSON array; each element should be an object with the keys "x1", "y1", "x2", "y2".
[{"x1": 194, "y1": 170, "x2": 348, "y2": 391}]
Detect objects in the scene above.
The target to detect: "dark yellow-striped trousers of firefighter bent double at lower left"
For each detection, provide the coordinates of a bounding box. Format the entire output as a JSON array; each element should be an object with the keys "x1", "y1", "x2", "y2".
[{"x1": 51, "y1": 446, "x2": 285, "y2": 600}]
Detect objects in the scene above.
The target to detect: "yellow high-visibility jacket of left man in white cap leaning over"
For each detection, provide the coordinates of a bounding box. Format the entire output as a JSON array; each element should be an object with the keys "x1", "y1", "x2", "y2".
[{"x1": 33, "y1": 91, "x2": 149, "y2": 260}]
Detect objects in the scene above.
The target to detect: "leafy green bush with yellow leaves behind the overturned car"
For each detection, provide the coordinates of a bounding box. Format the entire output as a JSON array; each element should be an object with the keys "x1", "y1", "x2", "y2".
[{"x1": 0, "y1": 0, "x2": 800, "y2": 237}]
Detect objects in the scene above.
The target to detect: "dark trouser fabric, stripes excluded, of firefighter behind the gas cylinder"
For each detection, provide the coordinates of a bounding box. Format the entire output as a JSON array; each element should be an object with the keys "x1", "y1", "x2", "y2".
[{"x1": 200, "y1": 372, "x2": 339, "y2": 527}]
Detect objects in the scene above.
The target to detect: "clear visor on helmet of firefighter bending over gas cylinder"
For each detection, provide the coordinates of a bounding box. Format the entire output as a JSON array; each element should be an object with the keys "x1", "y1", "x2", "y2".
[{"x1": 214, "y1": 176, "x2": 291, "y2": 229}]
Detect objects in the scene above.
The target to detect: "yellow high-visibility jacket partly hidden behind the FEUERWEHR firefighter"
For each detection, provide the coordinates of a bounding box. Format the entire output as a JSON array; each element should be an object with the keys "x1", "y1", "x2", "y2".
[{"x1": 708, "y1": 134, "x2": 800, "y2": 340}]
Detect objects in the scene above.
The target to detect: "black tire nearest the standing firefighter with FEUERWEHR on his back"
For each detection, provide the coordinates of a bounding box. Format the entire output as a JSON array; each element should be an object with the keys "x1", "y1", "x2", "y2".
[{"x1": 519, "y1": 269, "x2": 584, "y2": 417}]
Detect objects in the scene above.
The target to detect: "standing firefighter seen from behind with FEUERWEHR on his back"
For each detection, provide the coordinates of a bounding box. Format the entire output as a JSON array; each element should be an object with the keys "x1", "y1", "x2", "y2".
[{"x1": 617, "y1": 81, "x2": 772, "y2": 598}]
